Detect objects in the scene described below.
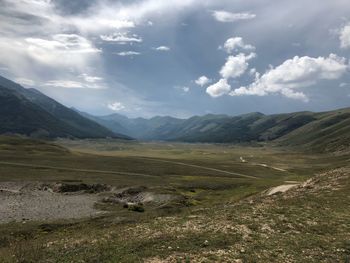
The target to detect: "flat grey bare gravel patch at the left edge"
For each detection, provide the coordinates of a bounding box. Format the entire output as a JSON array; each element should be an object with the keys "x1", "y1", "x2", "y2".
[{"x1": 0, "y1": 182, "x2": 103, "y2": 223}]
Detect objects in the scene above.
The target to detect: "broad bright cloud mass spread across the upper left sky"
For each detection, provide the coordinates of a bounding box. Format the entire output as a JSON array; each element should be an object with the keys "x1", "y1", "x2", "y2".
[{"x1": 0, "y1": 0, "x2": 197, "y2": 85}]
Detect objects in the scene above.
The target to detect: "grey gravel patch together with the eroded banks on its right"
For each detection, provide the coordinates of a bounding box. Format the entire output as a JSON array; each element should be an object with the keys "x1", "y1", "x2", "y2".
[{"x1": 0, "y1": 182, "x2": 183, "y2": 223}]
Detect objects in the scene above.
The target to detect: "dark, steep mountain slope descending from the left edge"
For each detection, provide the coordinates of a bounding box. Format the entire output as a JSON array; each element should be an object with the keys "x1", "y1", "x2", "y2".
[{"x1": 0, "y1": 76, "x2": 127, "y2": 138}]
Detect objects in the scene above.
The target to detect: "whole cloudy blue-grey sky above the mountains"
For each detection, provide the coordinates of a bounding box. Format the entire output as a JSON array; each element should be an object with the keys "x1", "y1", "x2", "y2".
[{"x1": 0, "y1": 0, "x2": 350, "y2": 118}]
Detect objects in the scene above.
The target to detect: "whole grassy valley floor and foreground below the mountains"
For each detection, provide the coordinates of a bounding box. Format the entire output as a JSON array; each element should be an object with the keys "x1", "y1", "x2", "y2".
[{"x1": 0, "y1": 137, "x2": 350, "y2": 262}]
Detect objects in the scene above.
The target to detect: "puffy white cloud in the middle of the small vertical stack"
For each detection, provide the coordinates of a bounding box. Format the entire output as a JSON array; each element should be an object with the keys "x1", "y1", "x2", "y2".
[{"x1": 220, "y1": 53, "x2": 256, "y2": 79}]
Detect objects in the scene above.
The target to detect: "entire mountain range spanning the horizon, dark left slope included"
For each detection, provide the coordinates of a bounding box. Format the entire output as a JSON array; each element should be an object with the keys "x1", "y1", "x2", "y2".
[{"x1": 0, "y1": 77, "x2": 350, "y2": 150}]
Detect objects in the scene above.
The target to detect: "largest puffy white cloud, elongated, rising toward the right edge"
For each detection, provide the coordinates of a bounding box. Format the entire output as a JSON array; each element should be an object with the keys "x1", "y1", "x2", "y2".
[{"x1": 230, "y1": 54, "x2": 348, "y2": 102}]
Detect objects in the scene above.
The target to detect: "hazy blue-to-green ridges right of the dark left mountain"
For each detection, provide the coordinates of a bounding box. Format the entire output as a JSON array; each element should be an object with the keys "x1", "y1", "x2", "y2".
[{"x1": 84, "y1": 109, "x2": 350, "y2": 153}]
